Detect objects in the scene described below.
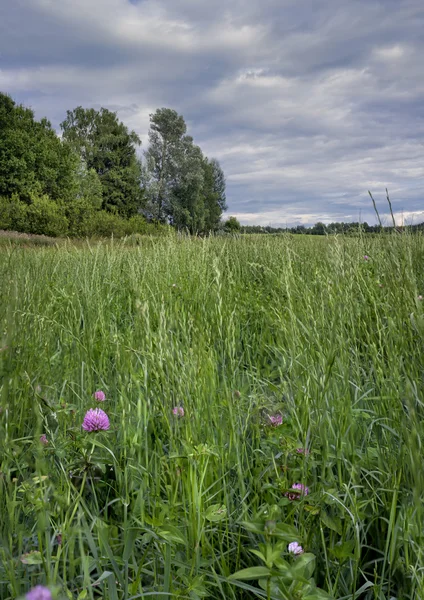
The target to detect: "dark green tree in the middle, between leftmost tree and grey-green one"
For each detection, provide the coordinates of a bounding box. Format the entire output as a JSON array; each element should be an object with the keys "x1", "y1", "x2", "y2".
[{"x1": 61, "y1": 106, "x2": 143, "y2": 218}]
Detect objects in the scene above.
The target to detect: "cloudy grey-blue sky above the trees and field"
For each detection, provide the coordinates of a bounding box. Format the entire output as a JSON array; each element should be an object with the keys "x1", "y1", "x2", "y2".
[{"x1": 0, "y1": 0, "x2": 424, "y2": 226}]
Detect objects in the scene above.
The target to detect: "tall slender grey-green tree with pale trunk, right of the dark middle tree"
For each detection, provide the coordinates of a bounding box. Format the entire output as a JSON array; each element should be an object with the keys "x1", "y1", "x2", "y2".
[{"x1": 145, "y1": 108, "x2": 187, "y2": 222}]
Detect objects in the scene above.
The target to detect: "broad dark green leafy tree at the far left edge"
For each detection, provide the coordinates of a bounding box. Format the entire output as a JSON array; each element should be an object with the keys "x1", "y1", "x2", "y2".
[{"x1": 0, "y1": 93, "x2": 77, "y2": 204}]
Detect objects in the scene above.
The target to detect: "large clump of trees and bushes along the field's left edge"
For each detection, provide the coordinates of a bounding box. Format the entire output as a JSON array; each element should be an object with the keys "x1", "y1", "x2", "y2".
[{"x1": 0, "y1": 93, "x2": 226, "y2": 237}]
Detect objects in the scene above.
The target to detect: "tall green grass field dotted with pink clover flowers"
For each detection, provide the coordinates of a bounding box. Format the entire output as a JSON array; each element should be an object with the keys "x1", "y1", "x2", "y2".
[{"x1": 0, "y1": 234, "x2": 424, "y2": 600}]
